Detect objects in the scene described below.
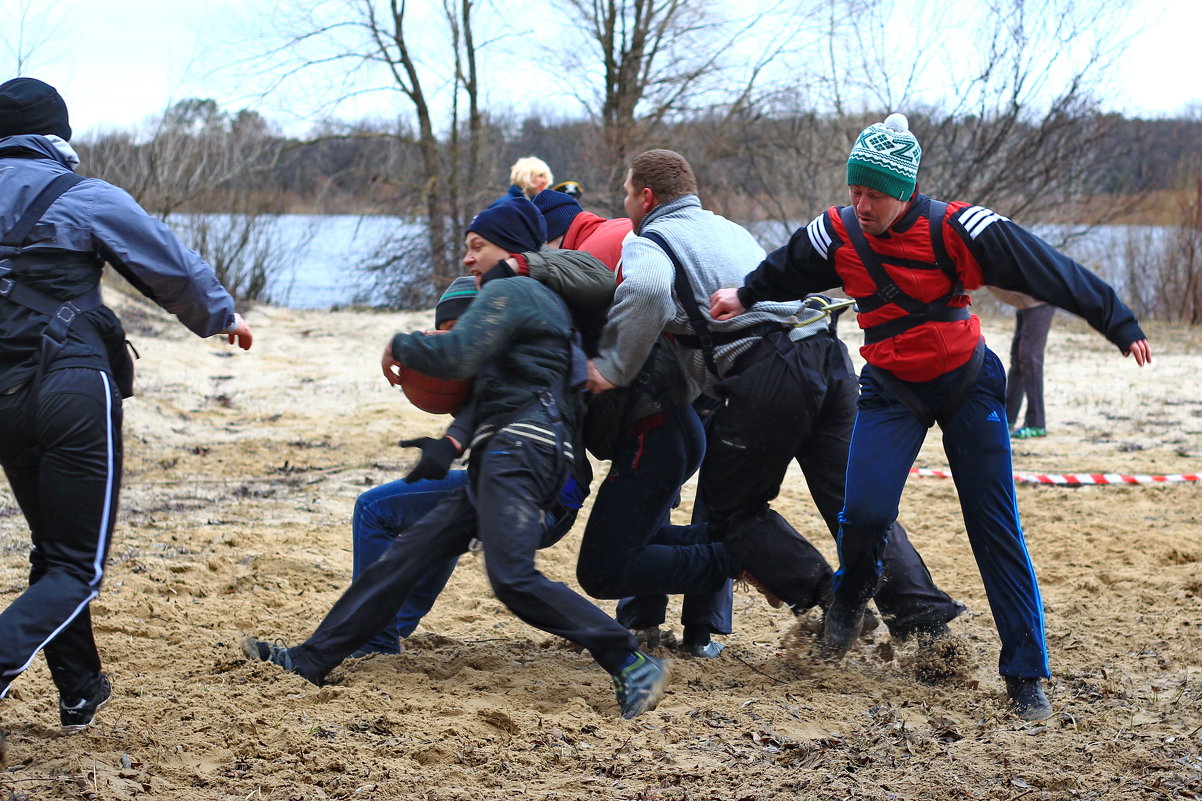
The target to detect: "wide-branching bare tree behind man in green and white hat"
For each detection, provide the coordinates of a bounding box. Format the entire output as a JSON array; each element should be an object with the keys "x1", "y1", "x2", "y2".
[{"x1": 734, "y1": 0, "x2": 1137, "y2": 238}]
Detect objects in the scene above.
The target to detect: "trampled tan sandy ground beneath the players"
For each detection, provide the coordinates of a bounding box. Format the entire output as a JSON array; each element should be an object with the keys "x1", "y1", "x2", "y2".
[{"x1": 0, "y1": 288, "x2": 1202, "y2": 801}]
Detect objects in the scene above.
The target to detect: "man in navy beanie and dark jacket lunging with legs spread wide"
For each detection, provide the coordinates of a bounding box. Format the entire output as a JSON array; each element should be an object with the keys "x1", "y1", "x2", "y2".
[{"x1": 236, "y1": 198, "x2": 667, "y2": 718}]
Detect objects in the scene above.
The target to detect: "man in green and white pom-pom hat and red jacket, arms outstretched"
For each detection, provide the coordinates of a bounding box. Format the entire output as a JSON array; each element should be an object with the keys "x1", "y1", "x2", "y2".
[{"x1": 710, "y1": 114, "x2": 1152, "y2": 720}]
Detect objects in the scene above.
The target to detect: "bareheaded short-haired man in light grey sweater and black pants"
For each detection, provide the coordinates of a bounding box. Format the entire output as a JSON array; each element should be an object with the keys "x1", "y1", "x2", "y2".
[{"x1": 589, "y1": 150, "x2": 960, "y2": 637}]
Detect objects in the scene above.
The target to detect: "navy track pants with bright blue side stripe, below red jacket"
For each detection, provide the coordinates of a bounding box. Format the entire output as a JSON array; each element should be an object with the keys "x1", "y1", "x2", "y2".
[{"x1": 835, "y1": 349, "x2": 1049, "y2": 677}]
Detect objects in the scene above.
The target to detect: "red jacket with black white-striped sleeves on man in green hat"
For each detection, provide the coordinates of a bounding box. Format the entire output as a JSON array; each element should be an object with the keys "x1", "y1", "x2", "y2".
[{"x1": 739, "y1": 195, "x2": 1144, "y2": 381}]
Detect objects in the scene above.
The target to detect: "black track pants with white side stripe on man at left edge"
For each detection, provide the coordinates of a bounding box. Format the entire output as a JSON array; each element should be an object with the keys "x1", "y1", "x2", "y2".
[{"x1": 0, "y1": 368, "x2": 121, "y2": 698}]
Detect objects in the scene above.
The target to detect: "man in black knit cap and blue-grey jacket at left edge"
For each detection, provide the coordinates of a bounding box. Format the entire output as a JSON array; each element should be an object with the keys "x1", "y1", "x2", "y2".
[{"x1": 0, "y1": 78, "x2": 251, "y2": 760}]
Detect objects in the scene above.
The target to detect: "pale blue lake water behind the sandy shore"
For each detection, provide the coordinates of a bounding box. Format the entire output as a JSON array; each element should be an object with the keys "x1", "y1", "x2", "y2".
[{"x1": 168, "y1": 214, "x2": 1165, "y2": 309}]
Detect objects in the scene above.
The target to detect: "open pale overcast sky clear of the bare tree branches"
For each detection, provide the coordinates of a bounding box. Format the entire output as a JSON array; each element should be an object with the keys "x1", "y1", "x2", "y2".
[{"x1": 0, "y1": 0, "x2": 1202, "y2": 135}]
